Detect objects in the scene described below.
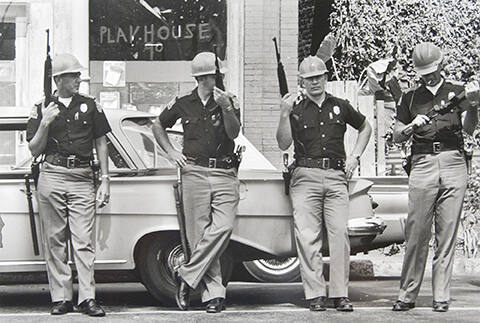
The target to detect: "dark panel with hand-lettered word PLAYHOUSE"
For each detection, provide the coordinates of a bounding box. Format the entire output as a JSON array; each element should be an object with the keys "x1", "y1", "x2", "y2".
[{"x1": 90, "y1": 0, "x2": 227, "y2": 61}]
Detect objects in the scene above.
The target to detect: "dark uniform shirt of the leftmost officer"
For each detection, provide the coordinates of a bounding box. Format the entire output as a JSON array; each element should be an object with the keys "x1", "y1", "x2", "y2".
[{"x1": 27, "y1": 94, "x2": 111, "y2": 158}]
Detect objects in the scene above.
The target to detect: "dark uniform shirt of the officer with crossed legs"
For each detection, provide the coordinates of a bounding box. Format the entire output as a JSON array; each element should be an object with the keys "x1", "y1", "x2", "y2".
[{"x1": 159, "y1": 88, "x2": 240, "y2": 158}]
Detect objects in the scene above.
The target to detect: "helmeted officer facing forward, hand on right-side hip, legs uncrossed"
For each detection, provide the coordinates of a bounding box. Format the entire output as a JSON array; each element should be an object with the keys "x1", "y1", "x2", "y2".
[{"x1": 277, "y1": 56, "x2": 371, "y2": 312}]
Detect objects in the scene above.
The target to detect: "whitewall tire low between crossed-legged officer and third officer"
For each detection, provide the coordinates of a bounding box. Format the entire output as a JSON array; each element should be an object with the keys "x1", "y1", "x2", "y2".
[{"x1": 243, "y1": 257, "x2": 300, "y2": 283}]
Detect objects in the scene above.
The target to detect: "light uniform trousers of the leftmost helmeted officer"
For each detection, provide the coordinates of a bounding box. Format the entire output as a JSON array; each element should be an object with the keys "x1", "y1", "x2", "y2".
[{"x1": 38, "y1": 162, "x2": 95, "y2": 304}]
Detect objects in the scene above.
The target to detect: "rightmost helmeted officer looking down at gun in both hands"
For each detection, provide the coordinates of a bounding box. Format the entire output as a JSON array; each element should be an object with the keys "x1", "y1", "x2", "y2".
[{"x1": 393, "y1": 42, "x2": 480, "y2": 312}]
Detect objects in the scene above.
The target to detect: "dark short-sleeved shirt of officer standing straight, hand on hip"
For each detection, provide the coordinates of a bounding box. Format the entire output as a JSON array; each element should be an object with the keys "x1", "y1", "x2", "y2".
[{"x1": 290, "y1": 93, "x2": 365, "y2": 158}]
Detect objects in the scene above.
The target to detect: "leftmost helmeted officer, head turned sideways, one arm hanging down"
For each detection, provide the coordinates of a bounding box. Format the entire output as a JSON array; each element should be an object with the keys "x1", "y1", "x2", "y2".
[{"x1": 27, "y1": 54, "x2": 111, "y2": 316}]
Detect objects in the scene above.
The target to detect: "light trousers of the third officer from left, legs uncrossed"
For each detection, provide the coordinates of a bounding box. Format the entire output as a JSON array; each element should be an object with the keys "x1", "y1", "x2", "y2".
[{"x1": 290, "y1": 167, "x2": 350, "y2": 299}]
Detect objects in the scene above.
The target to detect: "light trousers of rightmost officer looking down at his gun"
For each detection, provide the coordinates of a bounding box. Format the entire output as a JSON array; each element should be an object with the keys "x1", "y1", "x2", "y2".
[{"x1": 399, "y1": 151, "x2": 467, "y2": 302}]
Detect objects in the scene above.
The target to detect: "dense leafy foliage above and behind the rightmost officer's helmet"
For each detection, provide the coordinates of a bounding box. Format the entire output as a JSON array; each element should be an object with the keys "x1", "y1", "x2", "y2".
[{"x1": 330, "y1": 0, "x2": 480, "y2": 80}]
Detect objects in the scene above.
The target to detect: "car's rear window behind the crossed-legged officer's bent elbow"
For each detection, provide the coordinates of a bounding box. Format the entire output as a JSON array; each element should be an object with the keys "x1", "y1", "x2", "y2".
[{"x1": 122, "y1": 118, "x2": 183, "y2": 168}]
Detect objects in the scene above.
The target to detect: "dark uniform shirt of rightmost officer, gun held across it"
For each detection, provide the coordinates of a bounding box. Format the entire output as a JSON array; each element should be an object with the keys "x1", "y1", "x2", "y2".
[{"x1": 396, "y1": 81, "x2": 468, "y2": 147}]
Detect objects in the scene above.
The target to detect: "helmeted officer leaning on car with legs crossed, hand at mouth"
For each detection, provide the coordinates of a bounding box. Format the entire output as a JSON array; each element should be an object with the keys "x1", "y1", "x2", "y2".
[{"x1": 153, "y1": 52, "x2": 240, "y2": 313}]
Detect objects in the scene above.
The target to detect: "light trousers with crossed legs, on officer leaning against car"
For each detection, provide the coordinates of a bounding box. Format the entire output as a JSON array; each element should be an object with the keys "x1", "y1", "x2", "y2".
[{"x1": 178, "y1": 165, "x2": 239, "y2": 302}]
